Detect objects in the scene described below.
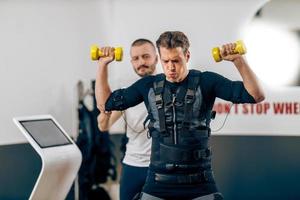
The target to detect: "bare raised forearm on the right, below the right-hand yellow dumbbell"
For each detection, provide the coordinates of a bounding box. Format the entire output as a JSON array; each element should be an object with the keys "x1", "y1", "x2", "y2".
[{"x1": 233, "y1": 57, "x2": 265, "y2": 103}]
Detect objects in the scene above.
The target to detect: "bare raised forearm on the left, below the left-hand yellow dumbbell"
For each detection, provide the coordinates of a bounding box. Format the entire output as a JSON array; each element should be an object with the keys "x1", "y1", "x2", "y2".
[{"x1": 95, "y1": 63, "x2": 111, "y2": 112}]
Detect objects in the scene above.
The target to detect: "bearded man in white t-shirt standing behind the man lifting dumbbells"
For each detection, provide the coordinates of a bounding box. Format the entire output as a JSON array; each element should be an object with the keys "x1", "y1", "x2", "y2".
[{"x1": 98, "y1": 38, "x2": 158, "y2": 200}]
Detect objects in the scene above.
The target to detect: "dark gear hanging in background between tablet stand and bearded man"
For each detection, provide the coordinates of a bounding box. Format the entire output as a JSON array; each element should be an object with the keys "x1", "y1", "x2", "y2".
[{"x1": 76, "y1": 80, "x2": 117, "y2": 200}]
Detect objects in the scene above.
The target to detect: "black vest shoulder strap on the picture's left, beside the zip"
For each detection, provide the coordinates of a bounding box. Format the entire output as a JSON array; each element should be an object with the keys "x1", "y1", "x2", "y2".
[{"x1": 153, "y1": 76, "x2": 166, "y2": 132}]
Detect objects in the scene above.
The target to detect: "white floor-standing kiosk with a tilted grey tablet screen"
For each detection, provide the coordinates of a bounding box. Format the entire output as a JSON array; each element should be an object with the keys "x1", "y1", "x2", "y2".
[{"x1": 13, "y1": 115, "x2": 82, "y2": 200}]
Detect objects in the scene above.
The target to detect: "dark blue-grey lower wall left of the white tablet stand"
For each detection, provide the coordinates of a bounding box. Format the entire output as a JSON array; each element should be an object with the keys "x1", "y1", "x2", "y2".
[{"x1": 0, "y1": 143, "x2": 42, "y2": 200}]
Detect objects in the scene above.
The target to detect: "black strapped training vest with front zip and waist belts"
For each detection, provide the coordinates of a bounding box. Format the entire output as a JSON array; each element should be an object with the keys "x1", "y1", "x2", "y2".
[{"x1": 148, "y1": 70, "x2": 211, "y2": 180}]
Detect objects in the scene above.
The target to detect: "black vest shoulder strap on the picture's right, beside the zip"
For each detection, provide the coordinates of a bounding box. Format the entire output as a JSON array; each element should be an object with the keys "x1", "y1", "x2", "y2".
[{"x1": 183, "y1": 76, "x2": 200, "y2": 130}]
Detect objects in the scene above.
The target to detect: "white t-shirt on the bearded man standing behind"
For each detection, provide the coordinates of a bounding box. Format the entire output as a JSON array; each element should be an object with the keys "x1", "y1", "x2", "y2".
[{"x1": 123, "y1": 103, "x2": 151, "y2": 167}]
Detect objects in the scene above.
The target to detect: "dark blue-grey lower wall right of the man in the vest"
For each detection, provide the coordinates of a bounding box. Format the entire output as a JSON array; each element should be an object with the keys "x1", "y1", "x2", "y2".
[{"x1": 211, "y1": 136, "x2": 300, "y2": 200}]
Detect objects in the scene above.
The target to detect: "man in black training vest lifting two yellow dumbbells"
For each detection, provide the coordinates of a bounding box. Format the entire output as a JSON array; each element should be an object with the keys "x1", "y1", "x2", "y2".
[{"x1": 96, "y1": 31, "x2": 264, "y2": 200}]
